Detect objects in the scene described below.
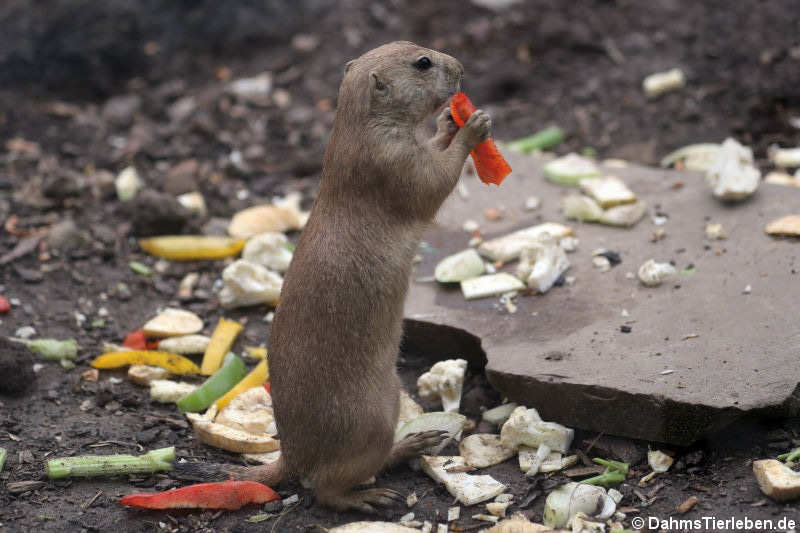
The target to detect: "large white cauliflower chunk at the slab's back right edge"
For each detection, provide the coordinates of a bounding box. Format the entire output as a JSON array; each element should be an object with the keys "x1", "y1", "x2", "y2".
[{"x1": 706, "y1": 138, "x2": 761, "y2": 201}]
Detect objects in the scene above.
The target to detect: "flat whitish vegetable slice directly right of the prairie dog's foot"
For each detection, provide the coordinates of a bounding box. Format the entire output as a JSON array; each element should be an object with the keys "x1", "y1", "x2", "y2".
[{"x1": 420, "y1": 455, "x2": 506, "y2": 505}]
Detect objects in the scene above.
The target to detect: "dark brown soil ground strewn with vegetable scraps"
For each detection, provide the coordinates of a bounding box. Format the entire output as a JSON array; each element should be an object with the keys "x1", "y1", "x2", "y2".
[{"x1": 0, "y1": 0, "x2": 800, "y2": 531}]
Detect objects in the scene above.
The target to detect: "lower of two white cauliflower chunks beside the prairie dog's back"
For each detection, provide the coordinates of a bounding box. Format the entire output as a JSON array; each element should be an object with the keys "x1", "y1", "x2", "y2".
[{"x1": 219, "y1": 259, "x2": 283, "y2": 309}]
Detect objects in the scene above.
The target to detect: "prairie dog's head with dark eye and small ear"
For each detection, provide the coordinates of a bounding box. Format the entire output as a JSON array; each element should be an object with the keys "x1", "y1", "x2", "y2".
[{"x1": 339, "y1": 41, "x2": 464, "y2": 124}]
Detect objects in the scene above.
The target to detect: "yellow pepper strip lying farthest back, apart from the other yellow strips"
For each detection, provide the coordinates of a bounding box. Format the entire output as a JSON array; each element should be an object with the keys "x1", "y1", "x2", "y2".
[{"x1": 139, "y1": 235, "x2": 245, "y2": 261}]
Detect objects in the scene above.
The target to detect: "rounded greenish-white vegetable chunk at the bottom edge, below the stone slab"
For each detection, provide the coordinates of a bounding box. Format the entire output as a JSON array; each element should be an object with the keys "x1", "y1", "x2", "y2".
[{"x1": 544, "y1": 483, "x2": 616, "y2": 528}]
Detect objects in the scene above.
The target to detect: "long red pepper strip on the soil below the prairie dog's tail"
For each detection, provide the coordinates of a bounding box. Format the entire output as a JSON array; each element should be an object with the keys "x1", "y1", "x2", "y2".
[{"x1": 119, "y1": 480, "x2": 280, "y2": 510}]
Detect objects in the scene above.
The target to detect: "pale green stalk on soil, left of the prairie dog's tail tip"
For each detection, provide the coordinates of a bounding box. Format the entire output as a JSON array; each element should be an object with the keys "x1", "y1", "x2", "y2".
[{"x1": 47, "y1": 446, "x2": 175, "y2": 479}]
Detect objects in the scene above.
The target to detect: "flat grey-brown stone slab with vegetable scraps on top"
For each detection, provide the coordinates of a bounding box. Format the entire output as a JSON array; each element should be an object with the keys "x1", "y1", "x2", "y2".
[{"x1": 406, "y1": 154, "x2": 800, "y2": 445}]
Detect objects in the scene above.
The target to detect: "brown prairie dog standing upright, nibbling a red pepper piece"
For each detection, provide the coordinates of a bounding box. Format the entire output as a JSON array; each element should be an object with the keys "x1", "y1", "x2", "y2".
[{"x1": 234, "y1": 42, "x2": 490, "y2": 511}]
